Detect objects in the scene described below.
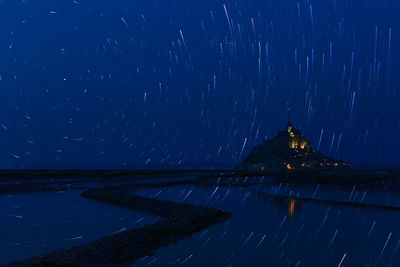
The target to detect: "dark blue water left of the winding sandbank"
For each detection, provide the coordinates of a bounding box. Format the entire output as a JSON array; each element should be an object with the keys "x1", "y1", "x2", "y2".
[{"x1": 0, "y1": 190, "x2": 160, "y2": 264}]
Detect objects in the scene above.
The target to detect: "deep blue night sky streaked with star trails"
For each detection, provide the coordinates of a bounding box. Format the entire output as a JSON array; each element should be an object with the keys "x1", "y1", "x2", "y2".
[{"x1": 0, "y1": 0, "x2": 400, "y2": 168}]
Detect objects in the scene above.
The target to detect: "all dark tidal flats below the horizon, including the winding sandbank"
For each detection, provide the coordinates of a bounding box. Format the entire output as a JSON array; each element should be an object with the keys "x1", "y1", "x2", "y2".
[{"x1": 0, "y1": 170, "x2": 400, "y2": 266}]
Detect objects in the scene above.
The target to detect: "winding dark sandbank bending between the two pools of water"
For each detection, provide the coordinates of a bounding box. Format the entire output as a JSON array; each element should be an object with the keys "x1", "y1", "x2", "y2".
[{"x1": 5, "y1": 189, "x2": 231, "y2": 266}]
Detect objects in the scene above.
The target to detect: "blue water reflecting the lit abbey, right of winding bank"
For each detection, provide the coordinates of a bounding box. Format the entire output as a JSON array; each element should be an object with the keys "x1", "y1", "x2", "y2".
[{"x1": 133, "y1": 186, "x2": 400, "y2": 266}]
